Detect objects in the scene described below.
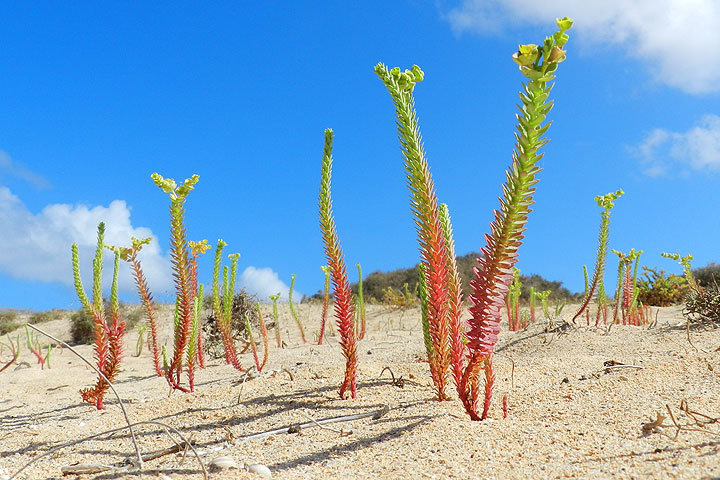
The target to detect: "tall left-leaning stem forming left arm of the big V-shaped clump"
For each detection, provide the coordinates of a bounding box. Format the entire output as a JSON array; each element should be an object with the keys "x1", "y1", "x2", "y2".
[{"x1": 375, "y1": 63, "x2": 455, "y2": 400}]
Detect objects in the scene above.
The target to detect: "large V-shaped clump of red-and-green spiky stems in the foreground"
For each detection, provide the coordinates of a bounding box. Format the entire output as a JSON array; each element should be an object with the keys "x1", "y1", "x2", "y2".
[{"x1": 375, "y1": 18, "x2": 572, "y2": 420}]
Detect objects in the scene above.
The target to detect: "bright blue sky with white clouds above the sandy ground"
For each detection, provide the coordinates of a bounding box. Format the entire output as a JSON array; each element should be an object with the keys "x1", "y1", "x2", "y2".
[{"x1": 0, "y1": 0, "x2": 720, "y2": 310}]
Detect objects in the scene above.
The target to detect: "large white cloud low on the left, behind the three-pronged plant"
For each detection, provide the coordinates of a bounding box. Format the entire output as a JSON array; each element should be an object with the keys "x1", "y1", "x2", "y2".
[{"x1": 0, "y1": 186, "x2": 172, "y2": 294}]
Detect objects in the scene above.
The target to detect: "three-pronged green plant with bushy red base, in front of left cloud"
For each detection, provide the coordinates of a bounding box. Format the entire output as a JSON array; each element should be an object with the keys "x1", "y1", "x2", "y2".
[{"x1": 72, "y1": 222, "x2": 125, "y2": 410}]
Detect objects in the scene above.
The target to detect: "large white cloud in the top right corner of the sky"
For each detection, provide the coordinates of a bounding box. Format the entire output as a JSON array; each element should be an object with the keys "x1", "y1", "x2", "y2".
[{"x1": 445, "y1": 0, "x2": 720, "y2": 93}]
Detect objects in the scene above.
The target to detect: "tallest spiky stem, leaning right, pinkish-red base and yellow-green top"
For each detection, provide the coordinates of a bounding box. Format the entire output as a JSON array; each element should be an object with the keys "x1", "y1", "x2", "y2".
[{"x1": 459, "y1": 17, "x2": 572, "y2": 420}]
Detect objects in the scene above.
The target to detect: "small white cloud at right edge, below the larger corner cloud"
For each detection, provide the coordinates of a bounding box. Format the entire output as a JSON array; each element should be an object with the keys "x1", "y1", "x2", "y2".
[{"x1": 632, "y1": 115, "x2": 720, "y2": 177}]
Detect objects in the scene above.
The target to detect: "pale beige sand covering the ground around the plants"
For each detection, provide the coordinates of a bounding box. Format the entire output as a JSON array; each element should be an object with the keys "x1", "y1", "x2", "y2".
[{"x1": 0, "y1": 305, "x2": 720, "y2": 479}]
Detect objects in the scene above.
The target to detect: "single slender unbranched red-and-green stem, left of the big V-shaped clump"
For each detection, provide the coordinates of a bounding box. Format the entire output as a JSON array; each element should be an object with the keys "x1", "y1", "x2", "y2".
[{"x1": 318, "y1": 128, "x2": 357, "y2": 399}]
